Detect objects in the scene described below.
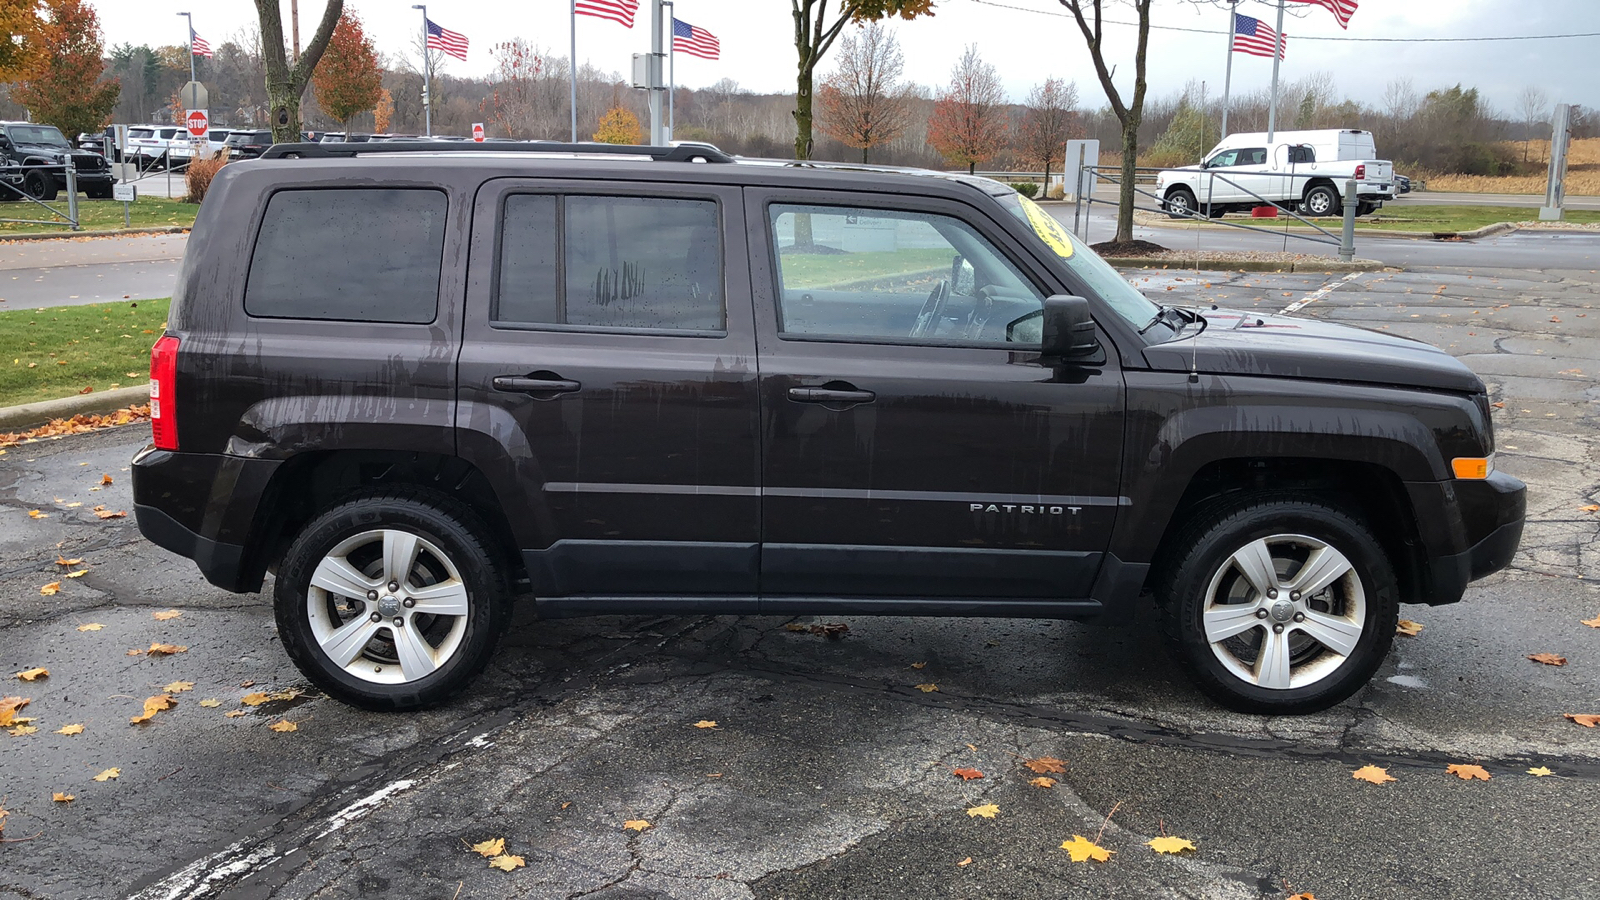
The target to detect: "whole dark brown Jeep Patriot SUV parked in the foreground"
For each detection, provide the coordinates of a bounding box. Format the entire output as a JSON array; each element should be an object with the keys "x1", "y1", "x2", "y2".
[{"x1": 133, "y1": 143, "x2": 1525, "y2": 713}]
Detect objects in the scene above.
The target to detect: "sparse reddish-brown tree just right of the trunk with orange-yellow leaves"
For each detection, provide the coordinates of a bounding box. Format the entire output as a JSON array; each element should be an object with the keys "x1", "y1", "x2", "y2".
[{"x1": 818, "y1": 22, "x2": 915, "y2": 162}]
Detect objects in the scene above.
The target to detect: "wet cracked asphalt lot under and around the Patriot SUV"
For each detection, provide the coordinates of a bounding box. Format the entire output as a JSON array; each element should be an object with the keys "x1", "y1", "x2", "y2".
[{"x1": 0, "y1": 239, "x2": 1600, "y2": 900}]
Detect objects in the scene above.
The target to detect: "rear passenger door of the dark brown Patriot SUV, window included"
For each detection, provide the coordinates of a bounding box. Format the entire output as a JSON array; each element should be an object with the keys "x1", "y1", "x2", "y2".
[{"x1": 458, "y1": 179, "x2": 760, "y2": 604}]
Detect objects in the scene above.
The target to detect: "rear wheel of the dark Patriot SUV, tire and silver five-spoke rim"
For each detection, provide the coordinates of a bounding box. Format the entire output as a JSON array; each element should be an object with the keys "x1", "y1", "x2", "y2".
[{"x1": 274, "y1": 488, "x2": 512, "y2": 709}]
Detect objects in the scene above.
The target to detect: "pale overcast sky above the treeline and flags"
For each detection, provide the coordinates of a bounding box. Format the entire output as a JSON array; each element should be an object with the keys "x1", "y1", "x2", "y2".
[{"x1": 88, "y1": 0, "x2": 1600, "y2": 112}]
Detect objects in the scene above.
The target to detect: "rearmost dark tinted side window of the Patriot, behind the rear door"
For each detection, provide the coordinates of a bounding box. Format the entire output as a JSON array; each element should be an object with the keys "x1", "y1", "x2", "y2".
[{"x1": 245, "y1": 187, "x2": 448, "y2": 323}]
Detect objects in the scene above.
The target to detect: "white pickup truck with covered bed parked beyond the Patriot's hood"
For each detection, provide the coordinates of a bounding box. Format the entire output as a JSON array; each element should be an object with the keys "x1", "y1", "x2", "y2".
[{"x1": 1155, "y1": 128, "x2": 1395, "y2": 219}]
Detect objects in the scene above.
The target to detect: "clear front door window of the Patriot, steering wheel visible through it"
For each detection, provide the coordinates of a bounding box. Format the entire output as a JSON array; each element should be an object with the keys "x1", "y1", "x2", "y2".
[{"x1": 770, "y1": 203, "x2": 1043, "y2": 346}]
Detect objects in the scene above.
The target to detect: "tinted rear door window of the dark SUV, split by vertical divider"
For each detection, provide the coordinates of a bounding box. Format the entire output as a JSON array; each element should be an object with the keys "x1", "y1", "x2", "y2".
[{"x1": 494, "y1": 194, "x2": 723, "y2": 331}]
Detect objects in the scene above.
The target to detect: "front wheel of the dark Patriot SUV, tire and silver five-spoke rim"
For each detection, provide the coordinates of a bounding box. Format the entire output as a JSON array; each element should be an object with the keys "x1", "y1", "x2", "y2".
[{"x1": 1157, "y1": 496, "x2": 1400, "y2": 714}]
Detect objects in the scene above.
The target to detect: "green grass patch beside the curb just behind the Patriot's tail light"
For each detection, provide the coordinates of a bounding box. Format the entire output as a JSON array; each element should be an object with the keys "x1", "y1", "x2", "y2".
[{"x1": 0, "y1": 299, "x2": 171, "y2": 407}]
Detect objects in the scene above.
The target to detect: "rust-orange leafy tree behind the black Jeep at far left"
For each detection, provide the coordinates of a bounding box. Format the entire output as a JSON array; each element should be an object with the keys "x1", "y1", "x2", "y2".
[{"x1": 11, "y1": 0, "x2": 122, "y2": 138}]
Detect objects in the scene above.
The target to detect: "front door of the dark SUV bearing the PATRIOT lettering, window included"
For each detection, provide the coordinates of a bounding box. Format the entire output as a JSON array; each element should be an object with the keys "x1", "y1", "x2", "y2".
[{"x1": 746, "y1": 189, "x2": 1123, "y2": 598}]
